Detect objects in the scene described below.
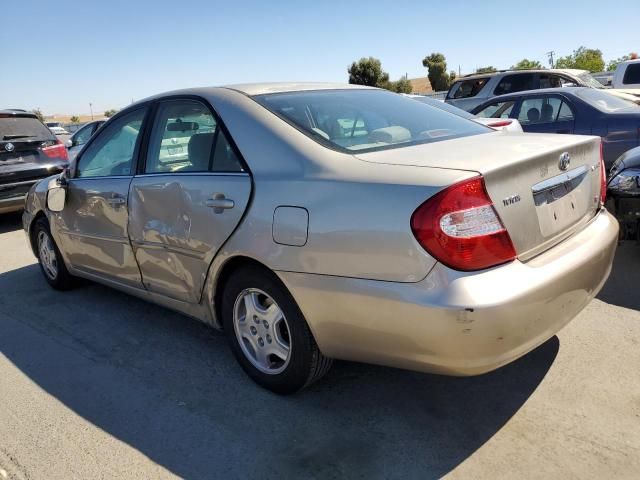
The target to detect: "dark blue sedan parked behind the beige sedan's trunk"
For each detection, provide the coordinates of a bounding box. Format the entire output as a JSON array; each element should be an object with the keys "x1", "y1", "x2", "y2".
[{"x1": 472, "y1": 87, "x2": 640, "y2": 169}]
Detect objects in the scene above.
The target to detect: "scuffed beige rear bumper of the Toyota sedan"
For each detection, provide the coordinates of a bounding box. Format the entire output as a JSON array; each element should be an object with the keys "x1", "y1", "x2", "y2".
[{"x1": 278, "y1": 209, "x2": 618, "y2": 375}]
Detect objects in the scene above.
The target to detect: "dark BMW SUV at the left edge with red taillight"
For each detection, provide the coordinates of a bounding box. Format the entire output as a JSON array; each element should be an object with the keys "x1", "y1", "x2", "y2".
[{"x1": 0, "y1": 110, "x2": 69, "y2": 213}]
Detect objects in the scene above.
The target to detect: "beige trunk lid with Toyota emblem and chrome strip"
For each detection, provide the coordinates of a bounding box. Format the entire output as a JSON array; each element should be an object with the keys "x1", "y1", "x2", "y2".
[{"x1": 356, "y1": 132, "x2": 600, "y2": 261}]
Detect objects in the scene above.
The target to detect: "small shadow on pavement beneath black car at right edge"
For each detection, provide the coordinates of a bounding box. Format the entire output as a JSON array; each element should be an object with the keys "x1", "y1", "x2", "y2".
[{"x1": 597, "y1": 241, "x2": 640, "y2": 310}]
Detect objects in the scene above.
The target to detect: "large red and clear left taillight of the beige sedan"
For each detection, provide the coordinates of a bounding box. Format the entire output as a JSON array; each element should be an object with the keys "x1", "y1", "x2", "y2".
[{"x1": 411, "y1": 177, "x2": 516, "y2": 271}]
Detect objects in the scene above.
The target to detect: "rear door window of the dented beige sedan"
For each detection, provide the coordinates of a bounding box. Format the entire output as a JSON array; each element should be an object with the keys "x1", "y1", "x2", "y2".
[{"x1": 145, "y1": 100, "x2": 242, "y2": 173}]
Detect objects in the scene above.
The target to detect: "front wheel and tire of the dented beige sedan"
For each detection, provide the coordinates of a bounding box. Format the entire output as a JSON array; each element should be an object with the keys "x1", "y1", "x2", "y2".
[{"x1": 33, "y1": 218, "x2": 73, "y2": 290}]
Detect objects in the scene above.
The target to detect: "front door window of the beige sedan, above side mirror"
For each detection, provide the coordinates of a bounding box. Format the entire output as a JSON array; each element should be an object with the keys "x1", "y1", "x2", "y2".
[{"x1": 76, "y1": 108, "x2": 147, "y2": 177}]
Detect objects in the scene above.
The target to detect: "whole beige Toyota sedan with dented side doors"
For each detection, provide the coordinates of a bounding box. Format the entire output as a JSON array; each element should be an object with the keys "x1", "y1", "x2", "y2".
[{"x1": 23, "y1": 84, "x2": 618, "y2": 393}]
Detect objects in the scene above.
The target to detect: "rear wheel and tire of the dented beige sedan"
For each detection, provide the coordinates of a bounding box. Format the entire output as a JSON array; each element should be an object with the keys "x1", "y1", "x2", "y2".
[{"x1": 221, "y1": 266, "x2": 332, "y2": 394}]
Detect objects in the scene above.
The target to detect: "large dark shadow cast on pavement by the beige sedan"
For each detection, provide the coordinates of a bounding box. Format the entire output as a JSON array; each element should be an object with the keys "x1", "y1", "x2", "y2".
[{"x1": 0, "y1": 265, "x2": 559, "y2": 479}]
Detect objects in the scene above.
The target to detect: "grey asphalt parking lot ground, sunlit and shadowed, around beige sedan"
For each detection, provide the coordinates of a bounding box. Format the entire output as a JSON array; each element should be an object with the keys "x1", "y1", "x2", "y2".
[{"x1": 0, "y1": 216, "x2": 640, "y2": 480}]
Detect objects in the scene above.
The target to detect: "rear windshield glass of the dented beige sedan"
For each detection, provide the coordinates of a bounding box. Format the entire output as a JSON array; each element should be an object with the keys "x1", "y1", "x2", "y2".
[{"x1": 254, "y1": 89, "x2": 491, "y2": 151}]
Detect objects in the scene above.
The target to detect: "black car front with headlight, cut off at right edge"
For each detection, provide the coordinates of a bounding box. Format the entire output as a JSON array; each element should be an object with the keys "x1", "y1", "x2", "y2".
[{"x1": 607, "y1": 147, "x2": 640, "y2": 238}]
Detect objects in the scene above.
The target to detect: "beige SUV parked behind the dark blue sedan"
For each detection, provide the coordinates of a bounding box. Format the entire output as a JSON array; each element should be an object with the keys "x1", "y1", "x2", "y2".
[{"x1": 445, "y1": 69, "x2": 604, "y2": 112}]
